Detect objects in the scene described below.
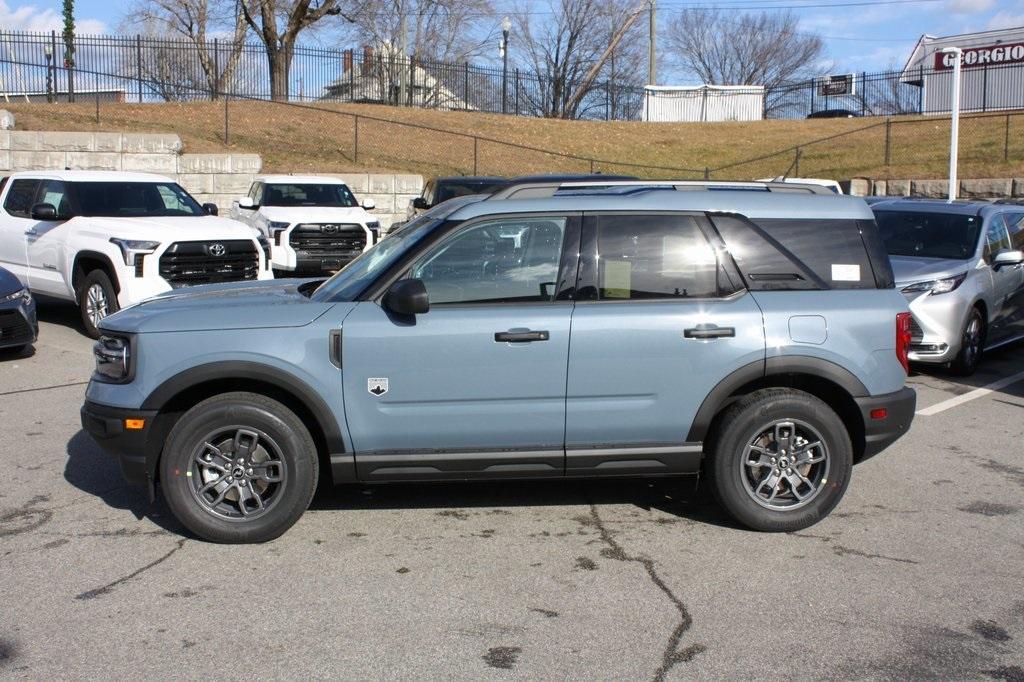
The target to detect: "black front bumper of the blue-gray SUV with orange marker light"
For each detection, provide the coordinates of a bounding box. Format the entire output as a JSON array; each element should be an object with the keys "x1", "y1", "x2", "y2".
[{"x1": 81, "y1": 400, "x2": 157, "y2": 485}]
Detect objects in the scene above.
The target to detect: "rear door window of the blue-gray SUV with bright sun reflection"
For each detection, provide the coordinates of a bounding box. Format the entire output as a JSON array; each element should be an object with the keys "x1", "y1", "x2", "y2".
[{"x1": 597, "y1": 215, "x2": 731, "y2": 300}]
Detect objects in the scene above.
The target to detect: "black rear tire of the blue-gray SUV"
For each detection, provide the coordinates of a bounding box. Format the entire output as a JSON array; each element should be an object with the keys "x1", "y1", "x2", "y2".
[{"x1": 706, "y1": 388, "x2": 853, "y2": 532}]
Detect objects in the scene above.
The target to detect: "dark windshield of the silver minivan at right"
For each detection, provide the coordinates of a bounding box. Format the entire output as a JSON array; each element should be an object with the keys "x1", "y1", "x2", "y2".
[{"x1": 874, "y1": 211, "x2": 981, "y2": 260}]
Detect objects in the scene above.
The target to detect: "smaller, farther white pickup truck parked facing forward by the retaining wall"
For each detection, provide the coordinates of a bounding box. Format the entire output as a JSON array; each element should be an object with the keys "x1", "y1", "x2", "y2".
[{"x1": 231, "y1": 175, "x2": 380, "y2": 275}]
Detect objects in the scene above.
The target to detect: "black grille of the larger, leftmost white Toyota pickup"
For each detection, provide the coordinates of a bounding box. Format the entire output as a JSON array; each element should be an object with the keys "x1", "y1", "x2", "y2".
[{"x1": 160, "y1": 240, "x2": 259, "y2": 288}]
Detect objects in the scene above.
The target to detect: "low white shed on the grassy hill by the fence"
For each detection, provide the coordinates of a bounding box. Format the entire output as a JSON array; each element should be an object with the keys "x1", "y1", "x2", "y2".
[{"x1": 643, "y1": 85, "x2": 765, "y2": 123}]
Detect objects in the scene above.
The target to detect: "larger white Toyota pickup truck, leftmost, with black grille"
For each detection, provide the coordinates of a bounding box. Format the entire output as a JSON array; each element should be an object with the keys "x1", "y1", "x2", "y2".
[{"x1": 0, "y1": 171, "x2": 273, "y2": 338}]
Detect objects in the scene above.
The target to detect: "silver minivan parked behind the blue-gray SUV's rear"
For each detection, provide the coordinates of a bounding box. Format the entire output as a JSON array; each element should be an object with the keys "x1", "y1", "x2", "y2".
[{"x1": 871, "y1": 199, "x2": 1024, "y2": 375}]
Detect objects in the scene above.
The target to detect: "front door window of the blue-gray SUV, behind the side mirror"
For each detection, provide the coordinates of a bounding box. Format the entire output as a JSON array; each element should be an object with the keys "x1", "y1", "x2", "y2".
[{"x1": 412, "y1": 217, "x2": 566, "y2": 305}]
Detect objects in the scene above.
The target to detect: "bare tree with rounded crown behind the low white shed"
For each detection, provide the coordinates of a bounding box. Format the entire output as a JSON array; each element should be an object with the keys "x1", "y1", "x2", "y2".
[{"x1": 665, "y1": 9, "x2": 824, "y2": 110}]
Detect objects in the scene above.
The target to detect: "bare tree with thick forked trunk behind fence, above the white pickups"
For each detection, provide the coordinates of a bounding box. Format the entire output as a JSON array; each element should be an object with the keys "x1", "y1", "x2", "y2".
[{"x1": 240, "y1": 0, "x2": 354, "y2": 100}]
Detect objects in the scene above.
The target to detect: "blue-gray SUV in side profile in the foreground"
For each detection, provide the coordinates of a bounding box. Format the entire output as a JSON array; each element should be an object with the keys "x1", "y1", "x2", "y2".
[{"x1": 82, "y1": 181, "x2": 915, "y2": 542}]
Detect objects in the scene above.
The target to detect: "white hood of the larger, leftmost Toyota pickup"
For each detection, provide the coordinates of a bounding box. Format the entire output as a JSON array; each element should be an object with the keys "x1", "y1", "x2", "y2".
[{"x1": 74, "y1": 215, "x2": 259, "y2": 244}]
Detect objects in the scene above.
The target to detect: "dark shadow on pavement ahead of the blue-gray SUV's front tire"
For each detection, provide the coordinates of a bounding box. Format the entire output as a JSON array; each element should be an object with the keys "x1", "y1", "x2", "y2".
[{"x1": 65, "y1": 431, "x2": 190, "y2": 535}]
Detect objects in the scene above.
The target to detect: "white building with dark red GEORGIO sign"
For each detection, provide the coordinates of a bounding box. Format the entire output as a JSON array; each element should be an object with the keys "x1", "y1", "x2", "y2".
[{"x1": 900, "y1": 27, "x2": 1024, "y2": 114}]
